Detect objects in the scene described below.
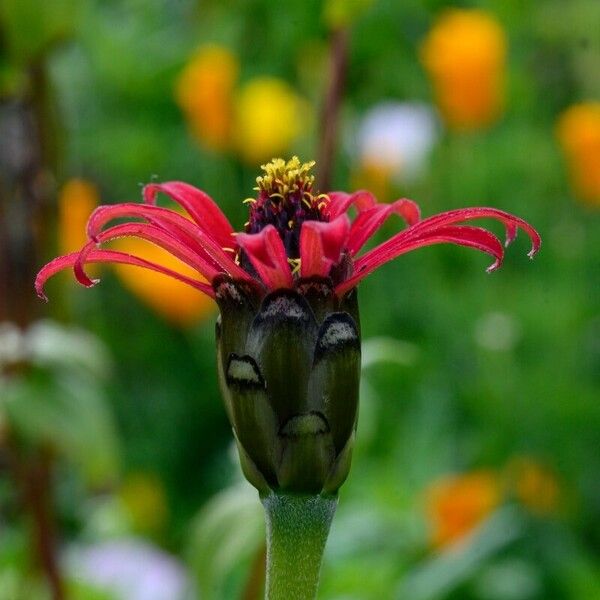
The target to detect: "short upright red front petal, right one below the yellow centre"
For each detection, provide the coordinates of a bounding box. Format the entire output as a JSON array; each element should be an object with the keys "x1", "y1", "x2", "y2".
[{"x1": 300, "y1": 214, "x2": 350, "y2": 277}]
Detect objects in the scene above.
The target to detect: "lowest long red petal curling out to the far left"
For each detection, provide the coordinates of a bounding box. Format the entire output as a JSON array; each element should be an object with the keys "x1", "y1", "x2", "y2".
[{"x1": 35, "y1": 250, "x2": 215, "y2": 301}]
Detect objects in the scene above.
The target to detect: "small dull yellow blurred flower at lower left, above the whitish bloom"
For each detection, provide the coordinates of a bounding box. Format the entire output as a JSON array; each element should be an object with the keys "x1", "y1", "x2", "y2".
[{"x1": 119, "y1": 473, "x2": 169, "y2": 533}]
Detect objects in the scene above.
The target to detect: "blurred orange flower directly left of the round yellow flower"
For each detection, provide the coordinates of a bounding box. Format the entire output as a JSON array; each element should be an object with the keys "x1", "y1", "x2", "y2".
[{"x1": 175, "y1": 45, "x2": 239, "y2": 150}]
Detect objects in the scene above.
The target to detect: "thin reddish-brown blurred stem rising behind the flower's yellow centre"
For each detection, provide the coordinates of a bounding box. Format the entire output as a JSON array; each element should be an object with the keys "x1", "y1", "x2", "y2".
[{"x1": 318, "y1": 28, "x2": 350, "y2": 191}]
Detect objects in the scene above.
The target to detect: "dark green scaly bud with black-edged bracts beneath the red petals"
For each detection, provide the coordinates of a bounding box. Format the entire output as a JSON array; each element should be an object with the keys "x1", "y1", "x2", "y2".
[{"x1": 214, "y1": 277, "x2": 360, "y2": 495}]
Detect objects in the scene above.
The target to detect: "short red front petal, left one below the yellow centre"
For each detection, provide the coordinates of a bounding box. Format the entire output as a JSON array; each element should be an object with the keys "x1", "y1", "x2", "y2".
[{"x1": 236, "y1": 225, "x2": 293, "y2": 290}]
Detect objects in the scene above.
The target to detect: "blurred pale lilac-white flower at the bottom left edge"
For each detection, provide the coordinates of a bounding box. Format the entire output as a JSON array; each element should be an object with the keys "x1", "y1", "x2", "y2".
[{"x1": 67, "y1": 538, "x2": 190, "y2": 600}]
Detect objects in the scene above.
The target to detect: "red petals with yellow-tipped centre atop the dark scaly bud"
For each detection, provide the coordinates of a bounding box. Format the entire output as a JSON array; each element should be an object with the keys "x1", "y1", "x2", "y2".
[{"x1": 36, "y1": 157, "x2": 541, "y2": 297}]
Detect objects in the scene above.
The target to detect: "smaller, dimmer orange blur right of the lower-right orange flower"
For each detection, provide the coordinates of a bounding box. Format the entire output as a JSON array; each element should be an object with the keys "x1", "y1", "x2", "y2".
[{"x1": 508, "y1": 457, "x2": 560, "y2": 514}]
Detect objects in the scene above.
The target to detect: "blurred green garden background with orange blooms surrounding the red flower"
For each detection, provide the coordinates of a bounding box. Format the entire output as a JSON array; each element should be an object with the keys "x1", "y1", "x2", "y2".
[{"x1": 0, "y1": 0, "x2": 600, "y2": 600}]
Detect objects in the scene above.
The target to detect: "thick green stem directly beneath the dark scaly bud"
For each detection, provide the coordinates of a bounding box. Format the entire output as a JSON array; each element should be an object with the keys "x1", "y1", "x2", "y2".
[{"x1": 262, "y1": 494, "x2": 337, "y2": 600}]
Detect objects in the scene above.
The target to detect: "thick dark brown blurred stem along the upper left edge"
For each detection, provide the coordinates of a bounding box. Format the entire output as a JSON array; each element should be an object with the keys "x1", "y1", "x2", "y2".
[{"x1": 0, "y1": 62, "x2": 55, "y2": 327}]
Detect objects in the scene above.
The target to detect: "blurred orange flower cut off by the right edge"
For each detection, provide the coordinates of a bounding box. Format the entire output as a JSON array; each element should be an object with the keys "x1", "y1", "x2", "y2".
[{"x1": 556, "y1": 102, "x2": 600, "y2": 206}]
